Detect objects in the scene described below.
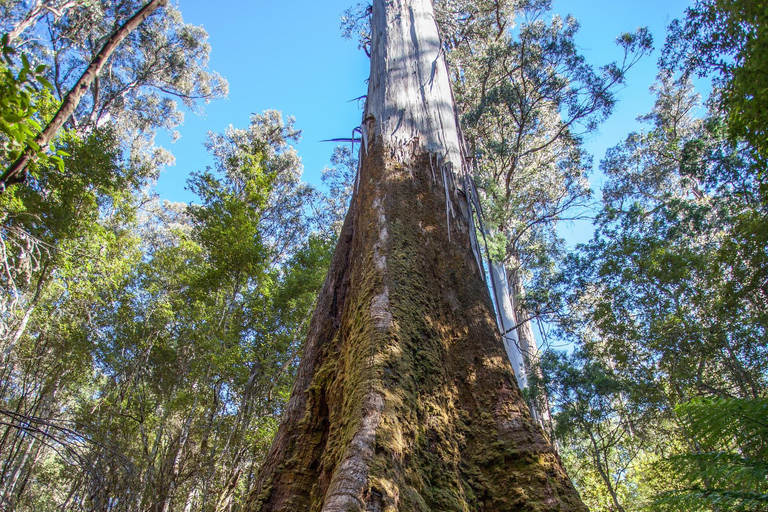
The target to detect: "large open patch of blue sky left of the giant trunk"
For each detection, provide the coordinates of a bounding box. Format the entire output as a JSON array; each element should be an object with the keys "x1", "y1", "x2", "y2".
[{"x1": 157, "y1": 0, "x2": 368, "y2": 201}]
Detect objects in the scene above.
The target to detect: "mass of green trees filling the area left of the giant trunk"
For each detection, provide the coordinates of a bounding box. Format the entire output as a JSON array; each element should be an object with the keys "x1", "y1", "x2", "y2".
[{"x1": 0, "y1": 105, "x2": 334, "y2": 512}]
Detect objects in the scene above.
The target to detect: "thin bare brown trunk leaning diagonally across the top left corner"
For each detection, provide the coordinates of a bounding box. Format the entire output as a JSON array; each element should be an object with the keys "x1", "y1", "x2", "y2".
[{"x1": 0, "y1": 0, "x2": 168, "y2": 193}]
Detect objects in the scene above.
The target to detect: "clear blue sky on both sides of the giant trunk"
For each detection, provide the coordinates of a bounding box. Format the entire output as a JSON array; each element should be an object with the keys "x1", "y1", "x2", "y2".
[{"x1": 157, "y1": 0, "x2": 691, "y2": 222}]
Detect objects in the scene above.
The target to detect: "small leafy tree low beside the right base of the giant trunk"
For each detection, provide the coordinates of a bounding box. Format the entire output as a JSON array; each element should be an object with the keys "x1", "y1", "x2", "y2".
[{"x1": 526, "y1": 351, "x2": 660, "y2": 512}]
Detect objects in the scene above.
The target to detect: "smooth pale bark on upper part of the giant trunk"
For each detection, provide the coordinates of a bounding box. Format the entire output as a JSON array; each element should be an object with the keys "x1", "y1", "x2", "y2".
[{"x1": 363, "y1": 0, "x2": 462, "y2": 167}]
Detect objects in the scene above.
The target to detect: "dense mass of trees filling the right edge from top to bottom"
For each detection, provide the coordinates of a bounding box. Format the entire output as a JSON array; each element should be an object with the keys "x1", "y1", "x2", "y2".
[{"x1": 533, "y1": 0, "x2": 768, "y2": 511}]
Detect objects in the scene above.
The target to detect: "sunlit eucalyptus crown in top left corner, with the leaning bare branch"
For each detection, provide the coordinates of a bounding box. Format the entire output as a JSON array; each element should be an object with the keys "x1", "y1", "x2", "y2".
[{"x1": 3, "y1": 0, "x2": 227, "y2": 185}]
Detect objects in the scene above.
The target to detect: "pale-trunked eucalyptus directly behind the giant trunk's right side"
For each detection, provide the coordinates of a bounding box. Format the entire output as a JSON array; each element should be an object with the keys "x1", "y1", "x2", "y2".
[{"x1": 342, "y1": 0, "x2": 651, "y2": 408}]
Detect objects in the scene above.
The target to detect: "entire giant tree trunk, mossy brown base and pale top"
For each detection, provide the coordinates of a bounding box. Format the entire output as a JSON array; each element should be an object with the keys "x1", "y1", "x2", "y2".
[{"x1": 246, "y1": 0, "x2": 586, "y2": 512}]
